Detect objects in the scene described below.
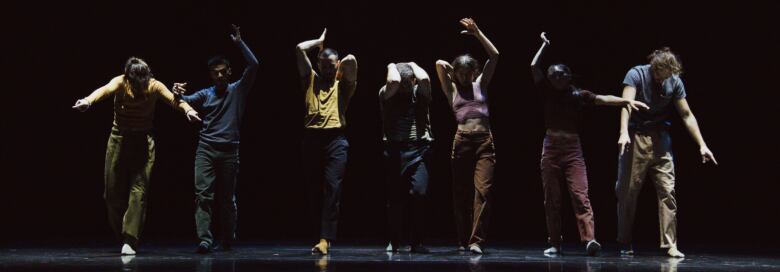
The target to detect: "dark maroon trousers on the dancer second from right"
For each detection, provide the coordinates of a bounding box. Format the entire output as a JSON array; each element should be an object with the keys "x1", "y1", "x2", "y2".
[{"x1": 541, "y1": 135, "x2": 594, "y2": 246}]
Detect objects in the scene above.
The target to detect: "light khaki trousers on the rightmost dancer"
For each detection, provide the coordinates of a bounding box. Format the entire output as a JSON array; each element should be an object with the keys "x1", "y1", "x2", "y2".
[{"x1": 615, "y1": 130, "x2": 677, "y2": 248}]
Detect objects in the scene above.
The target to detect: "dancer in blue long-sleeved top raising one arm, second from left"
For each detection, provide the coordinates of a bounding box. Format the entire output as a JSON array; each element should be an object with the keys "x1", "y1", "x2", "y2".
[{"x1": 173, "y1": 25, "x2": 258, "y2": 253}]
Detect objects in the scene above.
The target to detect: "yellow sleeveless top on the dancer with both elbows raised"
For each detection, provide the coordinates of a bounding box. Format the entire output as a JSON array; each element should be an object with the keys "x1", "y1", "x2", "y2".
[{"x1": 303, "y1": 71, "x2": 347, "y2": 129}]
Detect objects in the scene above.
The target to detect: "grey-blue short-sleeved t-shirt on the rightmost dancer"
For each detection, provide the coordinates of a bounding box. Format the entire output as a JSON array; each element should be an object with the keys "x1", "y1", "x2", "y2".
[{"x1": 623, "y1": 64, "x2": 686, "y2": 130}]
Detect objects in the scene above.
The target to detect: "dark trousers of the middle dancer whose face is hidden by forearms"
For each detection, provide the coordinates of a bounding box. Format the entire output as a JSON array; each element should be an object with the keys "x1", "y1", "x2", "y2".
[{"x1": 384, "y1": 141, "x2": 431, "y2": 246}]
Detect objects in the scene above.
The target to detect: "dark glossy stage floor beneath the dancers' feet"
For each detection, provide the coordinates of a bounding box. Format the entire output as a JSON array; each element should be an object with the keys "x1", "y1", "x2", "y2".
[{"x1": 0, "y1": 244, "x2": 780, "y2": 272}]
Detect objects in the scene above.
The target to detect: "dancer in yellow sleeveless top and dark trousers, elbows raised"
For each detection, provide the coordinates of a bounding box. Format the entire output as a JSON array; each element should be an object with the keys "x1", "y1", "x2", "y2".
[{"x1": 296, "y1": 29, "x2": 357, "y2": 255}]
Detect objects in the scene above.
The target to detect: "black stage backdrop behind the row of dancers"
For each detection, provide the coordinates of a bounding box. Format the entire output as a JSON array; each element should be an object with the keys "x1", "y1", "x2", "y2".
[{"x1": 6, "y1": 1, "x2": 780, "y2": 248}]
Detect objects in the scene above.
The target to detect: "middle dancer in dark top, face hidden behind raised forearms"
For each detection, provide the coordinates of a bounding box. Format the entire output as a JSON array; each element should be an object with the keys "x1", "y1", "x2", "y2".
[{"x1": 379, "y1": 62, "x2": 433, "y2": 253}]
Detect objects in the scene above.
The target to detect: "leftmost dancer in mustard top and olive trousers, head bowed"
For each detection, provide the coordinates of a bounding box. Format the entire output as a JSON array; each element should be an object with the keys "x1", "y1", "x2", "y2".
[{"x1": 73, "y1": 57, "x2": 200, "y2": 255}]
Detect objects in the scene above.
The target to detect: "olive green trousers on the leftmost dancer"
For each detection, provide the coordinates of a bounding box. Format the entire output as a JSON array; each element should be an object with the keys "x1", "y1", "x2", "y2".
[{"x1": 103, "y1": 127, "x2": 154, "y2": 247}]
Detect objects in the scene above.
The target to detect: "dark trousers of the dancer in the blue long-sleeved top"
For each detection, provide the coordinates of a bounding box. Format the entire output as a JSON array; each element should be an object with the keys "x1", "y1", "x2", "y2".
[{"x1": 195, "y1": 142, "x2": 239, "y2": 244}]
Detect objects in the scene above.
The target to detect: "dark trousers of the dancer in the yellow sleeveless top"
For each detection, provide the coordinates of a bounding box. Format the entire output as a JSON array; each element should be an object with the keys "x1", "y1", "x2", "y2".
[{"x1": 302, "y1": 129, "x2": 349, "y2": 241}]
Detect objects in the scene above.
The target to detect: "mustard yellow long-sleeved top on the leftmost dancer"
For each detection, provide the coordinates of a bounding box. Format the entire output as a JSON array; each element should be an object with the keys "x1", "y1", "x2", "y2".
[{"x1": 84, "y1": 75, "x2": 192, "y2": 130}]
